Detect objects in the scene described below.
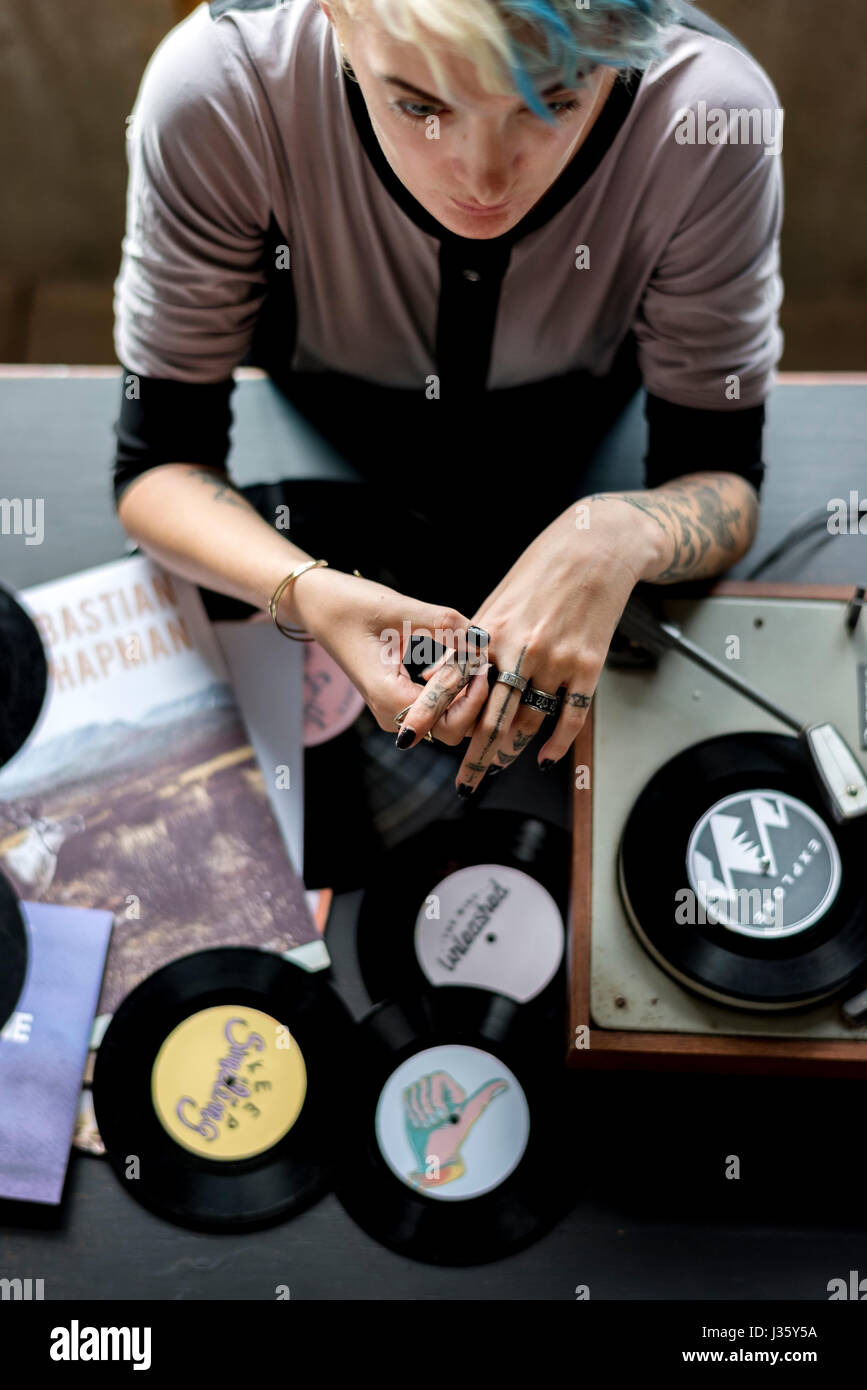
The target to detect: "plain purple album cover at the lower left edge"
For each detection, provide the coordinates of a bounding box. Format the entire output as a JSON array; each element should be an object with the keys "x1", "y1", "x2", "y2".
[{"x1": 0, "y1": 902, "x2": 111, "y2": 1205}]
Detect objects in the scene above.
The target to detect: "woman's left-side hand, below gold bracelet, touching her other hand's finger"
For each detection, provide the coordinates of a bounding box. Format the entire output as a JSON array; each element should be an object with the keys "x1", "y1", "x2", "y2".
[{"x1": 289, "y1": 569, "x2": 488, "y2": 744}]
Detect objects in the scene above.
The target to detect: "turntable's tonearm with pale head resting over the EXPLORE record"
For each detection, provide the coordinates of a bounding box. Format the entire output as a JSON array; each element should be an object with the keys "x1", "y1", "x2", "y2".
[{"x1": 620, "y1": 594, "x2": 867, "y2": 823}]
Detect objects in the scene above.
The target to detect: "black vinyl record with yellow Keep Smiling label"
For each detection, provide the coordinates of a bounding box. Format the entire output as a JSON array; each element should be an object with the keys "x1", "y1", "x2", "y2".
[{"x1": 93, "y1": 947, "x2": 353, "y2": 1232}]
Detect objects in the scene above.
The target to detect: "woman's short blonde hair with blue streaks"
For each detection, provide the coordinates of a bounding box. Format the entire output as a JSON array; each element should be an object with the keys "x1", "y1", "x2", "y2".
[{"x1": 331, "y1": 0, "x2": 671, "y2": 117}]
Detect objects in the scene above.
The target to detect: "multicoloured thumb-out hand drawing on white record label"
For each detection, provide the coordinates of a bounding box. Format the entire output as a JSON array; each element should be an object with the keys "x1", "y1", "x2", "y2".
[{"x1": 403, "y1": 1072, "x2": 509, "y2": 1188}]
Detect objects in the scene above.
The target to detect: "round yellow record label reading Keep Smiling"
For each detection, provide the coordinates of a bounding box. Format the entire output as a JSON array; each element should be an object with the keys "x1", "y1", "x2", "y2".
[{"x1": 150, "y1": 1004, "x2": 307, "y2": 1159}]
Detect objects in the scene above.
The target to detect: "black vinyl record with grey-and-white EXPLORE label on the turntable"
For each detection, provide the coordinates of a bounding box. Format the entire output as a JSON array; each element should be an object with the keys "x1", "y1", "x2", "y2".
[{"x1": 620, "y1": 733, "x2": 867, "y2": 1011}]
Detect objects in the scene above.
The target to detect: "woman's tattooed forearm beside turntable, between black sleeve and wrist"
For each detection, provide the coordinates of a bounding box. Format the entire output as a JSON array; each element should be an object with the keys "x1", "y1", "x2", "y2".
[{"x1": 584, "y1": 473, "x2": 759, "y2": 584}]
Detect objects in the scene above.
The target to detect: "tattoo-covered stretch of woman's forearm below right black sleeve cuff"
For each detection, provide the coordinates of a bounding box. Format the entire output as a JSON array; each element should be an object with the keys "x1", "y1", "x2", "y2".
[{"x1": 588, "y1": 473, "x2": 759, "y2": 582}]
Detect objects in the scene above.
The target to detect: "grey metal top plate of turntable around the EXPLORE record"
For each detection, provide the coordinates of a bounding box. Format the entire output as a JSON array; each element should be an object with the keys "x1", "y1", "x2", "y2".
[{"x1": 589, "y1": 585, "x2": 867, "y2": 1041}]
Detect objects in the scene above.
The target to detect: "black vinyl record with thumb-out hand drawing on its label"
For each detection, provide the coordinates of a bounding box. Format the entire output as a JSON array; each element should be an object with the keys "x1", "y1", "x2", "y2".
[{"x1": 336, "y1": 988, "x2": 577, "y2": 1265}]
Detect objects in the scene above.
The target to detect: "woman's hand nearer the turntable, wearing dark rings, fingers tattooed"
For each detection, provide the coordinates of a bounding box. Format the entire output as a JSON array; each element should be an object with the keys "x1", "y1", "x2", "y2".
[{"x1": 391, "y1": 502, "x2": 663, "y2": 796}]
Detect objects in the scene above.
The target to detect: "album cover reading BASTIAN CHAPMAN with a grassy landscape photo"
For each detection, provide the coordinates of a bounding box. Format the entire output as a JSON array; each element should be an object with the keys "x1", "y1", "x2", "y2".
[{"x1": 0, "y1": 556, "x2": 329, "y2": 1020}]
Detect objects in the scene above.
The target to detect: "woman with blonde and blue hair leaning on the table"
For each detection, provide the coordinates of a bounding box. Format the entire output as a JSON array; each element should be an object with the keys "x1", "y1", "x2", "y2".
[{"x1": 115, "y1": 0, "x2": 782, "y2": 796}]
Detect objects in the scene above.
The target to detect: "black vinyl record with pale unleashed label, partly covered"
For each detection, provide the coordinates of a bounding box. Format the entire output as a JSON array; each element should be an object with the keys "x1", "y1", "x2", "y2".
[{"x1": 357, "y1": 809, "x2": 571, "y2": 1004}]
